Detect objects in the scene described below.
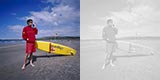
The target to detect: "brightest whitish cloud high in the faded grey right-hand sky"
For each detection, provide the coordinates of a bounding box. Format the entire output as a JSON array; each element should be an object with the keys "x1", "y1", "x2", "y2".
[{"x1": 110, "y1": 6, "x2": 153, "y2": 25}]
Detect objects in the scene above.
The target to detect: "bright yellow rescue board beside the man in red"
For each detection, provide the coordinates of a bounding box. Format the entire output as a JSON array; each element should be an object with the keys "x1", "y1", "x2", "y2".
[{"x1": 36, "y1": 41, "x2": 77, "y2": 55}]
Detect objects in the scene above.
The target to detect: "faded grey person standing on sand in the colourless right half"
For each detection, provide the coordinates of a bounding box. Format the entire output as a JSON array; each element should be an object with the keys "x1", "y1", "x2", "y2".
[{"x1": 102, "y1": 19, "x2": 118, "y2": 69}]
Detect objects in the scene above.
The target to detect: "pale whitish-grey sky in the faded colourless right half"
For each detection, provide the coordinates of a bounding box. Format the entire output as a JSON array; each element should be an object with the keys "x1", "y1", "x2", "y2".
[{"x1": 80, "y1": 0, "x2": 160, "y2": 39}]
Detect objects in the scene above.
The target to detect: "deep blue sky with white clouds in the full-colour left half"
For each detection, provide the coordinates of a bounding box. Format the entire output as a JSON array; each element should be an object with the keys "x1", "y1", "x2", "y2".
[{"x1": 0, "y1": 0, "x2": 80, "y2": 39}]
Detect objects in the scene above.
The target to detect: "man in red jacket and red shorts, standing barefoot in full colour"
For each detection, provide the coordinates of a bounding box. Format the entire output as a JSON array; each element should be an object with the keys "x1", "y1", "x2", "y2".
[{"x1": 22, "y1": 19, "x2": 38, "y2": 69}]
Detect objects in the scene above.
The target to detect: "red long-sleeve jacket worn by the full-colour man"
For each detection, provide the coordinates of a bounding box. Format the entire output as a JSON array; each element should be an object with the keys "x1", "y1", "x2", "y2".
[{"x1": 22, "y1": 26, "x2": 38, "y2": 42}]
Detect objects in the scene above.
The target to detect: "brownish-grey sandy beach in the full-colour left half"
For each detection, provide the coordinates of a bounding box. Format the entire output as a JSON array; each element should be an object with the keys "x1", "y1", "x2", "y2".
[{"x1": 0, "y1": 40, "x2": 80, "y2": 80}]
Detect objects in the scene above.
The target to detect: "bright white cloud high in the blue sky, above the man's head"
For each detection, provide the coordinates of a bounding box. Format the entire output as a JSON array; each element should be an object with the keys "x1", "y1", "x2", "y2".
[{"x1": 23, "y1": 5, "x2": 80, "y2": 26}]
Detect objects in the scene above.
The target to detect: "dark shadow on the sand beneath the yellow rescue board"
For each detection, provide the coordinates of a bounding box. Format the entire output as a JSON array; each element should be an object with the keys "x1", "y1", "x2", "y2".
[{"x1": 26, "y1": 54, "x2": 66, "y2": 66}]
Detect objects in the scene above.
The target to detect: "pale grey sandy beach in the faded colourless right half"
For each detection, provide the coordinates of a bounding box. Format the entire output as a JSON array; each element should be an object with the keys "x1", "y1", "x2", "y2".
[{"x1": 80, "y1": 40, "x2": 160, "y2": 80}]
